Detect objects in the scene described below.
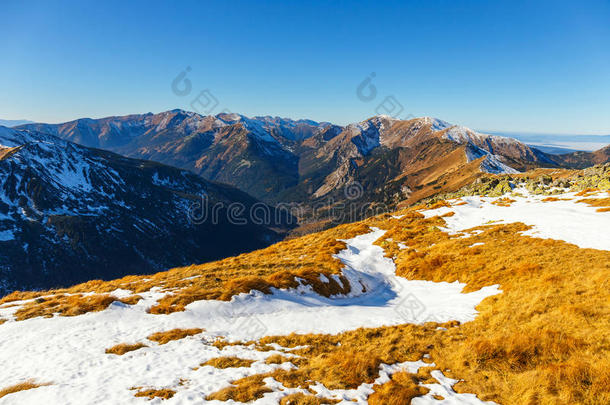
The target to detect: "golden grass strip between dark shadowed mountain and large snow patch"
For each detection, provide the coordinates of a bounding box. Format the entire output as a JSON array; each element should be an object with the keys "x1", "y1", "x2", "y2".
[{"x1": 0, "y1": 223, "x2": 368, "y2": 320}]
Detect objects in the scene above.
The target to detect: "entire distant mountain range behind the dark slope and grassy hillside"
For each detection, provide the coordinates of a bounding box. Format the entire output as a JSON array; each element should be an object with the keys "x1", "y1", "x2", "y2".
[{"x1": 21, "y1": 110, "x2": 556, "y2": 208}]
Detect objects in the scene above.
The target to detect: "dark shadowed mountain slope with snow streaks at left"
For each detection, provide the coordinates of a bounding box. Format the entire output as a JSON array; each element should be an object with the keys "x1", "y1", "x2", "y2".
[{"x1": 0, "y1": 127, "x2": 286, "y2": 295}]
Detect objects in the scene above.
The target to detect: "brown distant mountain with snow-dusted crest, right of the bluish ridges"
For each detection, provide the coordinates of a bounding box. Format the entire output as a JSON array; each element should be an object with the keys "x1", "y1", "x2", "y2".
[{"x1": 279, "y1": 116, "x2": 556, "y2": 218}]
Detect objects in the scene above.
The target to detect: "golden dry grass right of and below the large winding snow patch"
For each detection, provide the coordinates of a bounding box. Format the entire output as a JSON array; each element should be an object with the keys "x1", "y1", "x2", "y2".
[{"x1": 205, "y1": 210, "x2": 610, "y2": 404}]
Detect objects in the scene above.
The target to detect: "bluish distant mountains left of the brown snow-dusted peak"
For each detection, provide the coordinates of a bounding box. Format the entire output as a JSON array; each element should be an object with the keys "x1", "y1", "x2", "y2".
[{"x1": 22, "y1": 110, "x2": 330, "y2": 198}]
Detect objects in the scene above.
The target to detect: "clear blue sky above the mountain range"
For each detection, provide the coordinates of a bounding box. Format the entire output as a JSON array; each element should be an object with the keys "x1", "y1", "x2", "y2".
[{"x1": 0, "y1": 0, "x2": 610, "y2": 134}]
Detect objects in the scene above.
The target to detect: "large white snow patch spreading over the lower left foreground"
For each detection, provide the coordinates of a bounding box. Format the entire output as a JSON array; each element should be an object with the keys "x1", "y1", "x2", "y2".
[{"x1": 0, "y1": 229, "x2": 501, "y2": 405}]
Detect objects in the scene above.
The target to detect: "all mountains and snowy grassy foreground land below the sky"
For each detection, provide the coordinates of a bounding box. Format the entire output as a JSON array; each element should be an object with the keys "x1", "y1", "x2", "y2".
[{"x1": 0, "y1": 110, "x2": 610, "y2": 405}]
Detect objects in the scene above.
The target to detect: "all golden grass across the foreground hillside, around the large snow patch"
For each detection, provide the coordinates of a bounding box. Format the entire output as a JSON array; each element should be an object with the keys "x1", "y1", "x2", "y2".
[{"x1": 0, "y1": 169, "x2": 610, "y2": 404}]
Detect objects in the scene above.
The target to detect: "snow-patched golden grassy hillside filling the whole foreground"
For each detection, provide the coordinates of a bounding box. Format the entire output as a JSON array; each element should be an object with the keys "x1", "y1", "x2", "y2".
[{"x1": 0, "y1": 167, "x2": 610, "y2": 405}]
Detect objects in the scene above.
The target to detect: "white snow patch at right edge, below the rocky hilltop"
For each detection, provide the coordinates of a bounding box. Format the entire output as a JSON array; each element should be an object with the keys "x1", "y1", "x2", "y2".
[{"x1": 422, "y1": 189, "x2": 610, "y2": 250}]
